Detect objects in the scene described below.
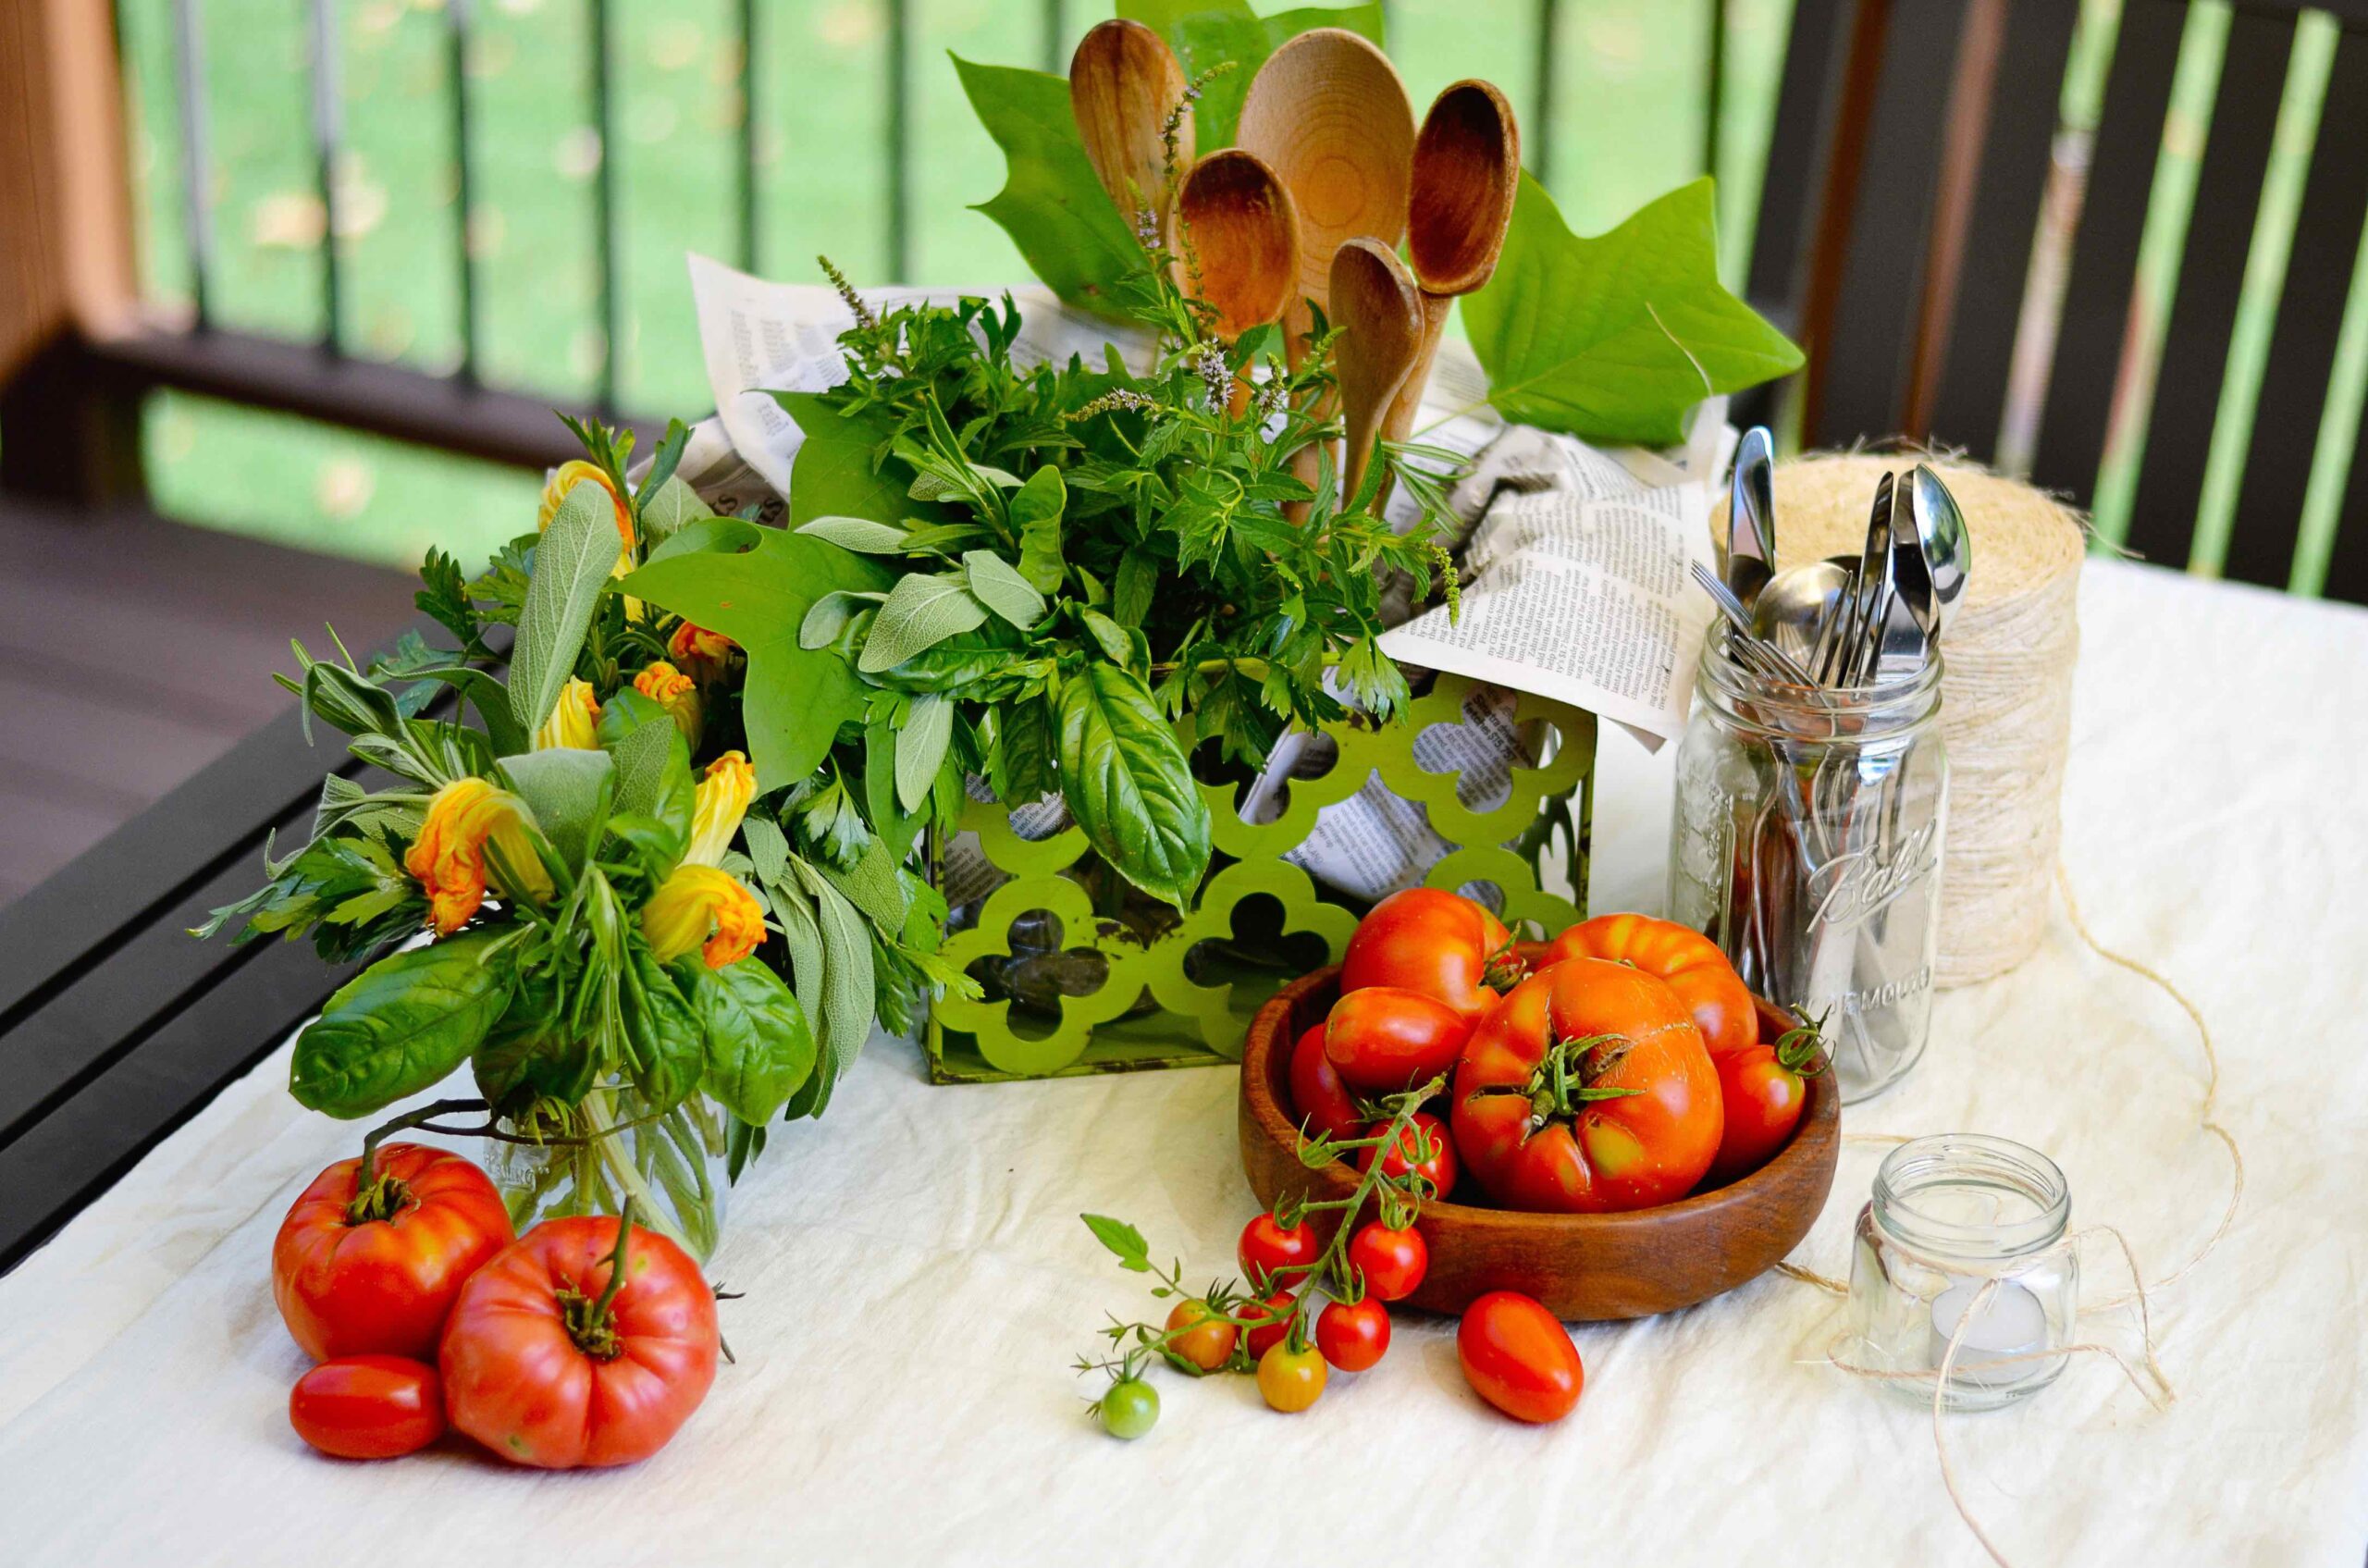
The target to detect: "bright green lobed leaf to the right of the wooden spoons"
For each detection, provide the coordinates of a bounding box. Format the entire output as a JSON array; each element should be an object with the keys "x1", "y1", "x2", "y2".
[{"x1": 1463, "y1": 175, "x2": 1802, "y2": 445}]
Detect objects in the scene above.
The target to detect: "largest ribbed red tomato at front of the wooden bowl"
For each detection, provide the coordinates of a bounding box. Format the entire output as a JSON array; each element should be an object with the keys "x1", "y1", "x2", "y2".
[{"x1": 1454, "y1": 959, "x2": 1724, "y2": 1215}]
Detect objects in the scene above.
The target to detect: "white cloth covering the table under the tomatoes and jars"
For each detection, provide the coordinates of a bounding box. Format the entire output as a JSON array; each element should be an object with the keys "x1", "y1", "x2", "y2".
[{"x1": 0, "y1": 563, "x2": 2368, "y2": 1568}]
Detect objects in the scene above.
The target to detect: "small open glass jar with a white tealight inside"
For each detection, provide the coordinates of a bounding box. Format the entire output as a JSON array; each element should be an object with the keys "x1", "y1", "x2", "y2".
[{"x1": 1849, "y1": 1132, "x2": 2079, "y2": 1409}]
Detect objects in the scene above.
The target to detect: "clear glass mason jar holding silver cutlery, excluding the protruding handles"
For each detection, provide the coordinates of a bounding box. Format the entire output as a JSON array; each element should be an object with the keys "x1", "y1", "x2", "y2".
[{"x1": 1670, "y1": 635, "x2": 1949, "y2": 1104}]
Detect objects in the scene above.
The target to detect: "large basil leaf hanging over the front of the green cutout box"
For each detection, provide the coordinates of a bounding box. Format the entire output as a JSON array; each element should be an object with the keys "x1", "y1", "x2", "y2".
[{"x1": 1058, "y1": 663, "x2": 1208, "y2": 909}]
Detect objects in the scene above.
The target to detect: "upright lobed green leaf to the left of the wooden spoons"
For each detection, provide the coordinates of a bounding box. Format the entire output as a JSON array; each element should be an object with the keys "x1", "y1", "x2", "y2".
[{"x1": 947, "y1": 55, "x2": 1143, "y2": 319}]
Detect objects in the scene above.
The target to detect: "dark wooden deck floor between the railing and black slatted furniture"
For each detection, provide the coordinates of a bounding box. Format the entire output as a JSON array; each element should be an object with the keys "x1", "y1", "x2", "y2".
[{"x1": 0, "y1": 502, "x2": 414, "y2": 905}]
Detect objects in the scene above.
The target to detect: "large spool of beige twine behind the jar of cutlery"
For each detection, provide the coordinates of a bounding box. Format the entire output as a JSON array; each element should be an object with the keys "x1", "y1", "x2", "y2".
[{"x1": 1712, "y1": 452, "x2": 2086, "y2": 985}]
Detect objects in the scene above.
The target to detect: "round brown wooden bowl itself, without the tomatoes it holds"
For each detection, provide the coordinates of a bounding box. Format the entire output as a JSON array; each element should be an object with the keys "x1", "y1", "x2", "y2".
[{"x1": 1240, "y1": 964, "x2": 1843, "y2": 1322}]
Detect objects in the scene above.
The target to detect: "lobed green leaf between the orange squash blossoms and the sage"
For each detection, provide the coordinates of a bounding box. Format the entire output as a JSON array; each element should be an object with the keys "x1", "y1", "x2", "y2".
[{"x1": 625, "y1": 528, "x2": 893, "y2": 789}]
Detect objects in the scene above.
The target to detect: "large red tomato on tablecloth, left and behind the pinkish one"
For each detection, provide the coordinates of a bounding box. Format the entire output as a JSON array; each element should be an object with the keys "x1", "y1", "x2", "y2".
[{"x1": 272, "y1": 1144, "x2": 512, "y2": 1362}]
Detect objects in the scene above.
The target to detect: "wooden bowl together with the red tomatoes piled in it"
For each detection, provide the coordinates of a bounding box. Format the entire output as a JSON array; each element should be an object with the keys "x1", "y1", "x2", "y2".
[{"x1": 1239, "y1": 888, "x2": 1840, "y2": 1322}]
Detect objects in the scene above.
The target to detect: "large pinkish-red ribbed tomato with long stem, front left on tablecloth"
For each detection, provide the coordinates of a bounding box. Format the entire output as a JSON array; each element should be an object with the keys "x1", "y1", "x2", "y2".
[{"x1": 443, "y1": 1217, "x2": 718, "y2": 1471}]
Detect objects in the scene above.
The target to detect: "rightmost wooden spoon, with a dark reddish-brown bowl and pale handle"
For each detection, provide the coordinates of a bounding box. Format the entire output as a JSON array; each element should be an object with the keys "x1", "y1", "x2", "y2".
[{"x1": 1388, "y1": 80, "x2": 1521, "y2": 440}]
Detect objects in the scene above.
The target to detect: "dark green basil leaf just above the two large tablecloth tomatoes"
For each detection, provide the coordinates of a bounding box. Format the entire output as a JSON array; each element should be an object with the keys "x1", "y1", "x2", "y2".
[{"x1": 289, "y1": 931, "x2": 514, "y2": 1120}]
